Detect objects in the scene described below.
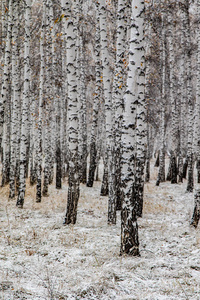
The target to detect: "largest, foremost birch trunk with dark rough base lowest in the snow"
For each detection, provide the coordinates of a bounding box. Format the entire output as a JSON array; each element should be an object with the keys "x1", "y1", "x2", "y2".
[{"x1": 121, "y1": 0, "x2": 144, "y2": 256}]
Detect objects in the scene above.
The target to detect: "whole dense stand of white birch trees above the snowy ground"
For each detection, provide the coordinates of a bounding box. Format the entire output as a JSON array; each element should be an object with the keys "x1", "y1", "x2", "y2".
[{"x1": 0, "y1": 0, "x2": 200, "y2": 256}]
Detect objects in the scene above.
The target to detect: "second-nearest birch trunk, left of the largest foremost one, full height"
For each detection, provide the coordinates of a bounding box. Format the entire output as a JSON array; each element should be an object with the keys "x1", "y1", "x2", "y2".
[{"x1": 62, "y1": 0, "x2": 79, "y2": 224}]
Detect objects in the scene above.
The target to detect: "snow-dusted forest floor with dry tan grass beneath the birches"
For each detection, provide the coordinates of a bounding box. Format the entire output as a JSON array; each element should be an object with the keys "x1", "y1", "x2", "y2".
[{"x1": 0, "y1": 165, "x2": 200, "y2": 300}]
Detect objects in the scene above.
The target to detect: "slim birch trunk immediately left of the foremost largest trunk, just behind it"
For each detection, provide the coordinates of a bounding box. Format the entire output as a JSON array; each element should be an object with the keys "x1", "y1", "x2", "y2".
[{"x1": 108, "y1": 0, "x2": 128, "y2": 214}]
